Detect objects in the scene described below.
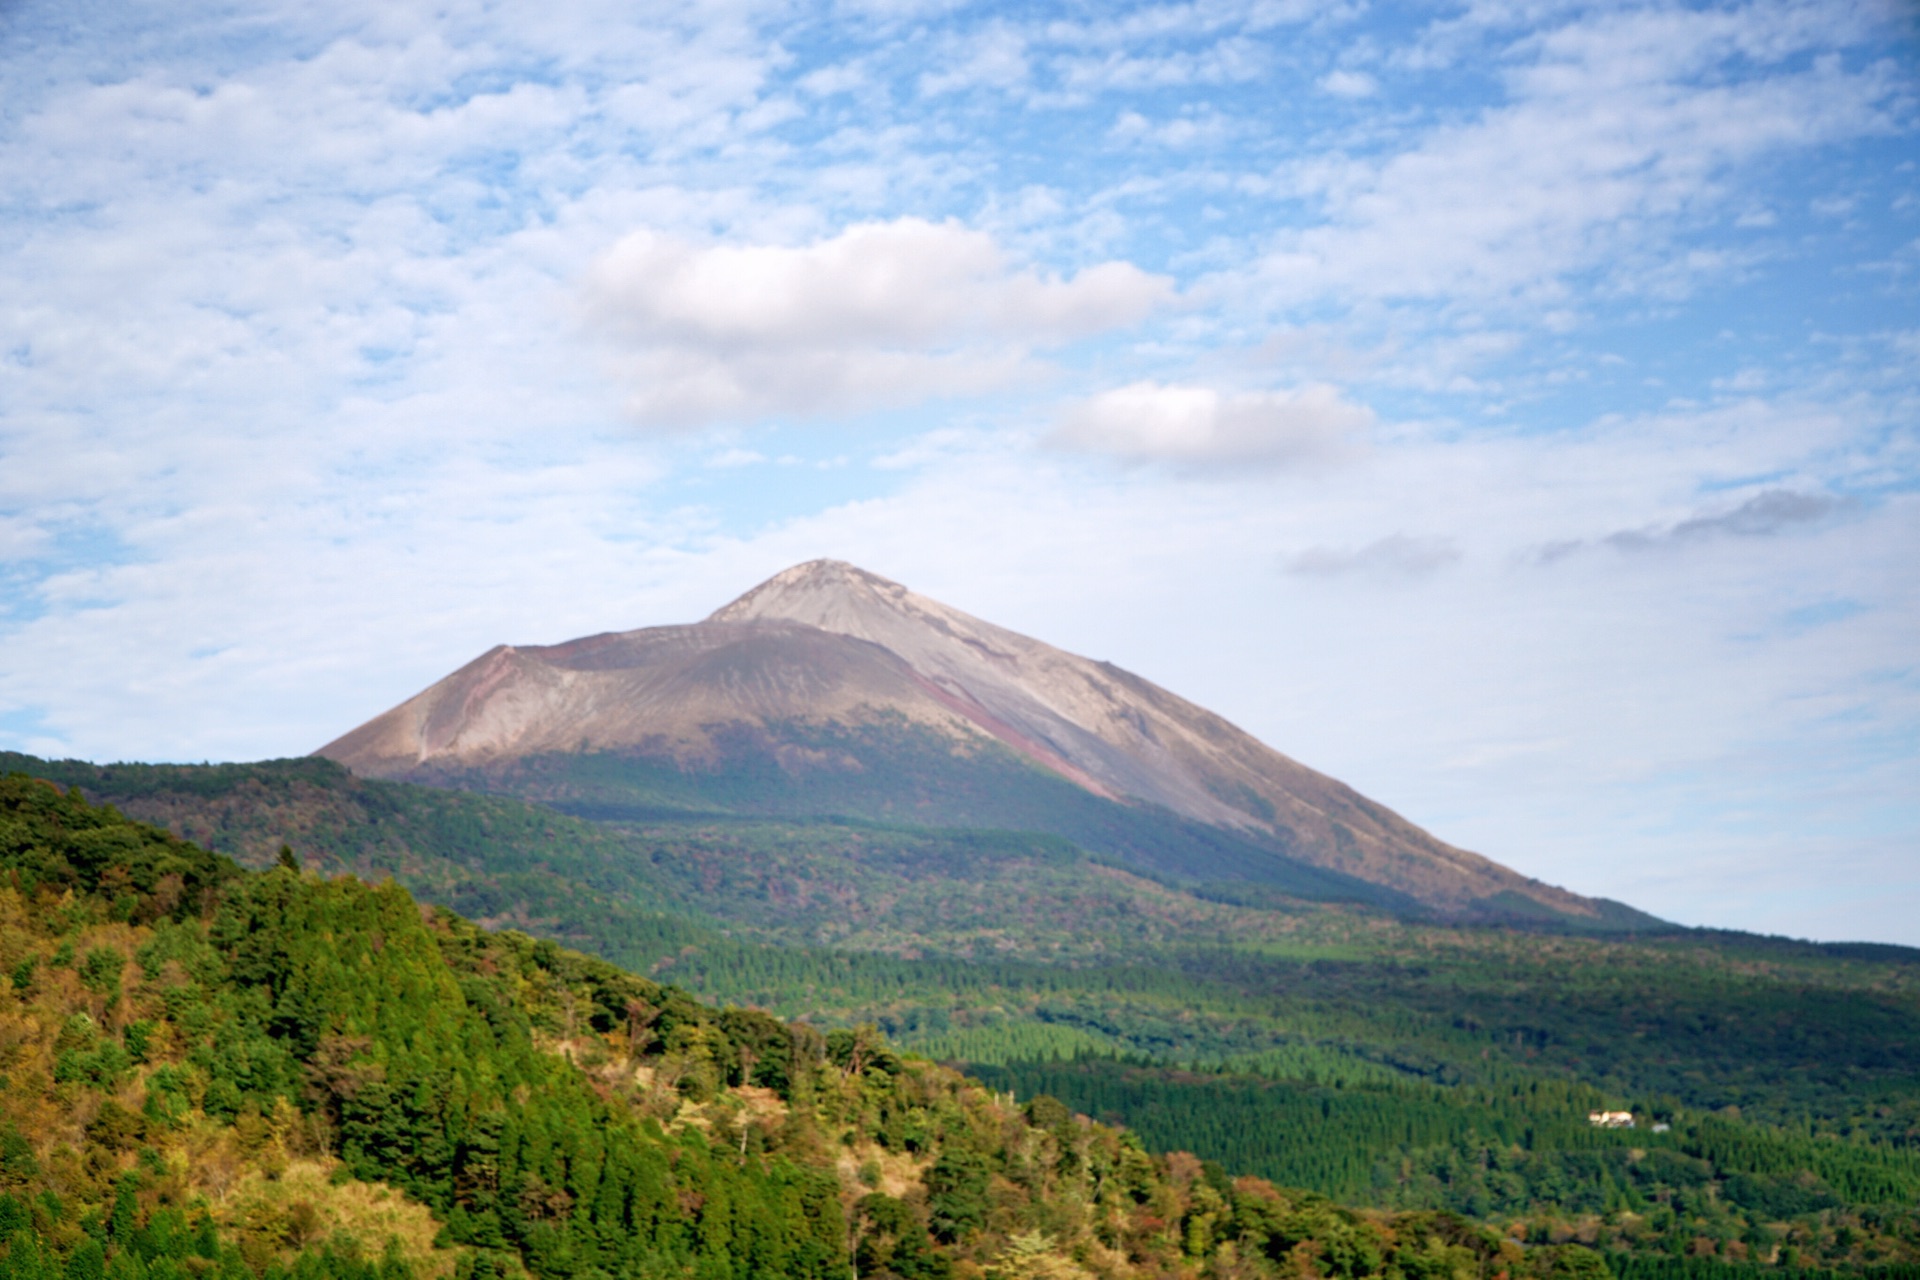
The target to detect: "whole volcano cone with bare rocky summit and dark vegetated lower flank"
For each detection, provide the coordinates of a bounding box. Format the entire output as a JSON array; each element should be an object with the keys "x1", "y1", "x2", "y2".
[{"x1": 317, "y1": 560, "x2": 1651, "y2": 927}]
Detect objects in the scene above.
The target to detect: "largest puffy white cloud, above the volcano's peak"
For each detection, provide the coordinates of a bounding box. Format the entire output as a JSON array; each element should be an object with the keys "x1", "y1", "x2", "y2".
[{"x1": 588, "y1": 217, "x2": 1173, "y2": 426}]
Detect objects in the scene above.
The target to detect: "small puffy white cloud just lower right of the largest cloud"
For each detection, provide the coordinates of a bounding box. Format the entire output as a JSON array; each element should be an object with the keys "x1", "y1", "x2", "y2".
[{"x1": 1048, "y1": 382, "x2": 1373, "y2": 466}]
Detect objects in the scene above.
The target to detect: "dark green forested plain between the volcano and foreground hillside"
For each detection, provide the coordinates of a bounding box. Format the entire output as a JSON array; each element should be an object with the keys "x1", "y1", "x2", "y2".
[{"x1": 3, "y1": 764, "x2": 1920, "y2": 1265}]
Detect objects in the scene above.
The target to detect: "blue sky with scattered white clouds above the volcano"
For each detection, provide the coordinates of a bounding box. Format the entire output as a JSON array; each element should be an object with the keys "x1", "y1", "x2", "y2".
[{"x1": 0, "y1": 0, "x2": 1920, "y2": 944}]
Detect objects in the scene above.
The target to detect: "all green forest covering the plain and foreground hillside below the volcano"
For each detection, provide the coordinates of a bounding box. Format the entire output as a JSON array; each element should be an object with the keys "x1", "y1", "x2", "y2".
[{"x1": 0, "y1": 758, "x2": 1920, "y2": 1280}]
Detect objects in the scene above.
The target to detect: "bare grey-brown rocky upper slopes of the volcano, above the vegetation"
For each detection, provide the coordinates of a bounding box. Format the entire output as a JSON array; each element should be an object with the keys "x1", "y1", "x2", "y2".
[{"x1": 317, "y1": 560, "x2": 1613, "y2": 919}]
